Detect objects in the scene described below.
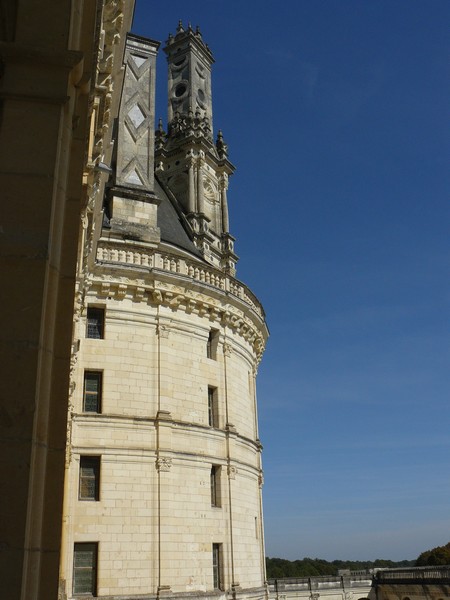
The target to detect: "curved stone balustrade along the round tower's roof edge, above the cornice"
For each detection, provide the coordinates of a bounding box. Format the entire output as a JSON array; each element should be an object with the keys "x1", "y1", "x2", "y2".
[{"x1": 97, "y1": 240, "x2": 265, "y2": 319}]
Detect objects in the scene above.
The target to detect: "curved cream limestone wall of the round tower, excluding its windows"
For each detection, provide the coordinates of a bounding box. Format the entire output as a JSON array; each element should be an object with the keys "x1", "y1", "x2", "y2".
[{"x1": 63, "y1": 240, "x2": 267, "y2": 598}]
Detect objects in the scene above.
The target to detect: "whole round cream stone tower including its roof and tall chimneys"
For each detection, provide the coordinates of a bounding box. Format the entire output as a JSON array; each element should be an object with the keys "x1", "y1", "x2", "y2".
[{"x1": 60, "y1": 24, "x2": 268, "y2": 599}]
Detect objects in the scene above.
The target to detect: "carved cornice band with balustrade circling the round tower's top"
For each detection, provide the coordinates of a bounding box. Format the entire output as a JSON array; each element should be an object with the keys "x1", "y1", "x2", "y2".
[{"x1": 90, "y1": 240, "x2": 268, "y2": 363}]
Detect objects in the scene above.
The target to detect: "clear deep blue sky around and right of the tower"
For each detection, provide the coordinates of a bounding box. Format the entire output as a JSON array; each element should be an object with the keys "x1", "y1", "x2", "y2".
[{"x1": 133, "y1": 0, "x2": 450, "y2": 560}]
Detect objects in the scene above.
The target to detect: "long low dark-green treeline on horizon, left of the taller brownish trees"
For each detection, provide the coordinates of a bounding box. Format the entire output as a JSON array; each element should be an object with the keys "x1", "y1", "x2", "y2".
[{"x1": 266, "y1": 557, "x2": 416, "y2": 579}]
